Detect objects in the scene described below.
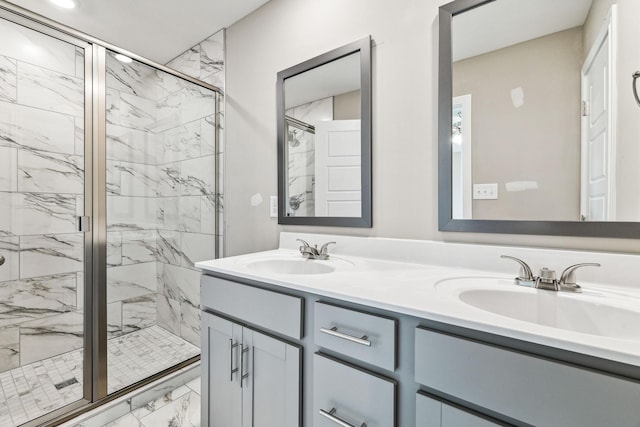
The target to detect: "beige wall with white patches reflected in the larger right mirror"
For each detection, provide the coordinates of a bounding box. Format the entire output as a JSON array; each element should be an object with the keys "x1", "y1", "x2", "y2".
[{"x1": 453, "y1": 27, "x2": 582, "y2": 221}]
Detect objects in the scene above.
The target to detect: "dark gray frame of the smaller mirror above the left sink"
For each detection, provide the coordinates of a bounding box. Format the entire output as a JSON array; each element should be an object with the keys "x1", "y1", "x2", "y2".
[{"x1": 276, "y1": 36, "x2": 372, "y2": 228}]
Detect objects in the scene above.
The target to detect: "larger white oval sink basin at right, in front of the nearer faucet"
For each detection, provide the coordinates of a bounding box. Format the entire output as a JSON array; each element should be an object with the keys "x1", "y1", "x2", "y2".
[{"x1": 437, "y1": 278, "x2": 640, "y2": 341}]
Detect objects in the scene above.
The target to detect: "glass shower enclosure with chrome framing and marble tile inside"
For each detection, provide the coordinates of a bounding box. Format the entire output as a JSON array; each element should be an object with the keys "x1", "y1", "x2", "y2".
[{"x1": 0, "y1": 4, "x2": 219, "y2": 426}]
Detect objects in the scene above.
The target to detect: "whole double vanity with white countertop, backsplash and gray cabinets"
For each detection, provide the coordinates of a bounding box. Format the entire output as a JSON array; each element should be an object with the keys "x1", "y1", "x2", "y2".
[{"x1": 196, "y1": 233, "x2": 640, "y2": 427}]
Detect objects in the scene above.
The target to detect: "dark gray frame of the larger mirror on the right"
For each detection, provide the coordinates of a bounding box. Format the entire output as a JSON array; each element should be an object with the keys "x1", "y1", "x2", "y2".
[{"x1": 438, "y1": 0, "x2": 640, "y2": 238}]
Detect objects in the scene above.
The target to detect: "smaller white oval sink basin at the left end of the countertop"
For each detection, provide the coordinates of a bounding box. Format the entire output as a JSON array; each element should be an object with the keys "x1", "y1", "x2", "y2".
[{"x1": 245, "y1": 257, "x2": 353, "y2": 274}]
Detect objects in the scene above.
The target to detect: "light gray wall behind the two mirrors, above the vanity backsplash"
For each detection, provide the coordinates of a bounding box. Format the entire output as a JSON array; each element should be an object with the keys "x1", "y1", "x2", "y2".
[{"x1": 225, "y1": 0, "x2": 640, "y2": 255}]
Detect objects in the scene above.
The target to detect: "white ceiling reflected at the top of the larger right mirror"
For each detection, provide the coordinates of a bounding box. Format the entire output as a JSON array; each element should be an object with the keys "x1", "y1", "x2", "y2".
[{"x1": 451, "y1": 0, "x2": 593, "y2": 61}]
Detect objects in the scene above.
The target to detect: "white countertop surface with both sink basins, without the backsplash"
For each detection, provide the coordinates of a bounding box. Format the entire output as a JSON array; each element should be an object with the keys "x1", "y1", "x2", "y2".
[{"x1": 212, "y1": 249, "x2": 640, "y2": 364}]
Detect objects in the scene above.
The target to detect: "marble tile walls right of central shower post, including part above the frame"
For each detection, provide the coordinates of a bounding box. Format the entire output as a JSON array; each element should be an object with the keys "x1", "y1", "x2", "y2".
[{"x1": 107, "y1": 32, "x2": 224, "y2": 345}]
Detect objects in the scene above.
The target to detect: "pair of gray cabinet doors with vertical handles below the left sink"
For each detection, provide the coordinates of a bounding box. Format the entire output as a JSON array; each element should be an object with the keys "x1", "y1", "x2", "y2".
[{"x1": 202, "y1": 312, "x2": 301, "y2": 427}]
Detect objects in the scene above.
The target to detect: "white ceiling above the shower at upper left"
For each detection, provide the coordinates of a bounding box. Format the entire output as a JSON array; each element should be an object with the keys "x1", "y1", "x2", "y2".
[{"x1": 5, "y1": 0, "x2": 268, "y2": 64}]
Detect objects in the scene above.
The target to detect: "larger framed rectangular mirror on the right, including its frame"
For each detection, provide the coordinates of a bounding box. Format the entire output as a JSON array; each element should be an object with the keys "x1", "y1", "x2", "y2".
[{"x1": 438, "y1": 0, "x2": 640, "y2": 237}]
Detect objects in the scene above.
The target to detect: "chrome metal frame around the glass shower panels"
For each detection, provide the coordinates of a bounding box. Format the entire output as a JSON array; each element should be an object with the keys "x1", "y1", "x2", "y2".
[{"x1": 0, "y1": 0, "x2": 223, "y2": 427}]
